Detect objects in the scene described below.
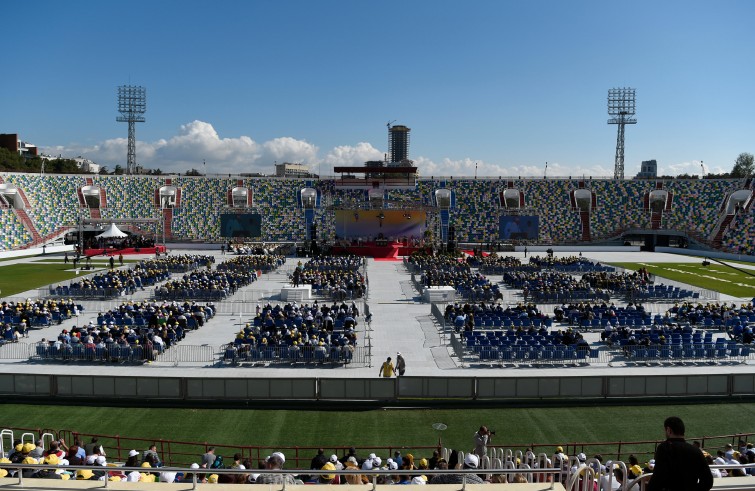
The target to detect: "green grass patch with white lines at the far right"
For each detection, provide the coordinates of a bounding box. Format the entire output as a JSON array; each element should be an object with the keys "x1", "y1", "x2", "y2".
[{"x1": 611, "y1": 261, "x2": 755, "y2": 298}]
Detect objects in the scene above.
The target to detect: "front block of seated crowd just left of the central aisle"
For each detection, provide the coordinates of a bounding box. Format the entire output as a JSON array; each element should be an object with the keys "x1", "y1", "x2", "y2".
[{"x1": 224, "y1": 302, "x2": 359, "y2": 362}]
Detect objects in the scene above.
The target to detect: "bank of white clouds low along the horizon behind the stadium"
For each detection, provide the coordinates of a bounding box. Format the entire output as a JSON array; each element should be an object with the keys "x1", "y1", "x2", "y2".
[{"x1": 41, "y1": 121, "x2": 704, "y2": 178}]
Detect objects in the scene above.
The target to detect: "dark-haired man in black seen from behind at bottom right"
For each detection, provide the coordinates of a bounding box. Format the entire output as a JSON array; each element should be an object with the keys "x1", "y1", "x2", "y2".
[{"x1": 646, "y1": 416, "x2": 713, "y2": 491}]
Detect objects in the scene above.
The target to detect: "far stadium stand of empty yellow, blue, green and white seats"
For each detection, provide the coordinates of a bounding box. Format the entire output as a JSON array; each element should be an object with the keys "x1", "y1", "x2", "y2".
[{"x1": 2, "y1": 173, "x2": 752, "y2": 248}]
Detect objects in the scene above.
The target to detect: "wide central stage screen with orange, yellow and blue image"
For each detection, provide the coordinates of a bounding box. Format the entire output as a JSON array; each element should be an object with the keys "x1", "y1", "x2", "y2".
[{"x1": 336, "y1": 210, "x2": 426, "y2": 240}]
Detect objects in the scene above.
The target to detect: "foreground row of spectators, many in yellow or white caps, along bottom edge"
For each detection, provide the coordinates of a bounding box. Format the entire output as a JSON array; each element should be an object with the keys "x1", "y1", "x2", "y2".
[{"x1": 0, "y1": 435, "x2": 744, "y2": 491}]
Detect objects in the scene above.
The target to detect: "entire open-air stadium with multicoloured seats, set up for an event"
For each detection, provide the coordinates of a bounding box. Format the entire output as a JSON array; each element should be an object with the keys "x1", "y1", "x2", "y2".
[{"x1": 0, "y1": 167, "x2": 755, "y2": 489}]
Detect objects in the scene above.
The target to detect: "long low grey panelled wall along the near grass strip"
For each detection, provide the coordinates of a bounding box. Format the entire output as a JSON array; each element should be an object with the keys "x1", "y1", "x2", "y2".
[{"x1": 0, "y1": 373, "x2": 755, "y2": 404}]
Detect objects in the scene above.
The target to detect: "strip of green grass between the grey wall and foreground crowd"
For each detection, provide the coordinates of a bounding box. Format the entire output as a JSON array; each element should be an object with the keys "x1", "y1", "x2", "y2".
[{"x1": 0, "y1": 403, "x2": 755, "y2": 464}]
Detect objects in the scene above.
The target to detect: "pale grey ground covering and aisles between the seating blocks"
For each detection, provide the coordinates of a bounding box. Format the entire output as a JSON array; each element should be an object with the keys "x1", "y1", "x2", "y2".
[{"x1": 0, "y1": 250, "x2": 752, "y2": 378}]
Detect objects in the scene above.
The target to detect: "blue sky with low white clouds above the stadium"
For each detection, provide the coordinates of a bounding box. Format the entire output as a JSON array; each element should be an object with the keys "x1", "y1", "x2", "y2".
[{"x1": 0, "y1": 0, "x2": 755, "y2": 177}]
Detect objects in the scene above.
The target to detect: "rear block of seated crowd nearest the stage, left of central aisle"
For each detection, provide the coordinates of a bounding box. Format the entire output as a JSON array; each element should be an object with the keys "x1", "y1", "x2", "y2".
[{"x1": 291, "y1": 255, "x2": 366, "y2": 301}]
